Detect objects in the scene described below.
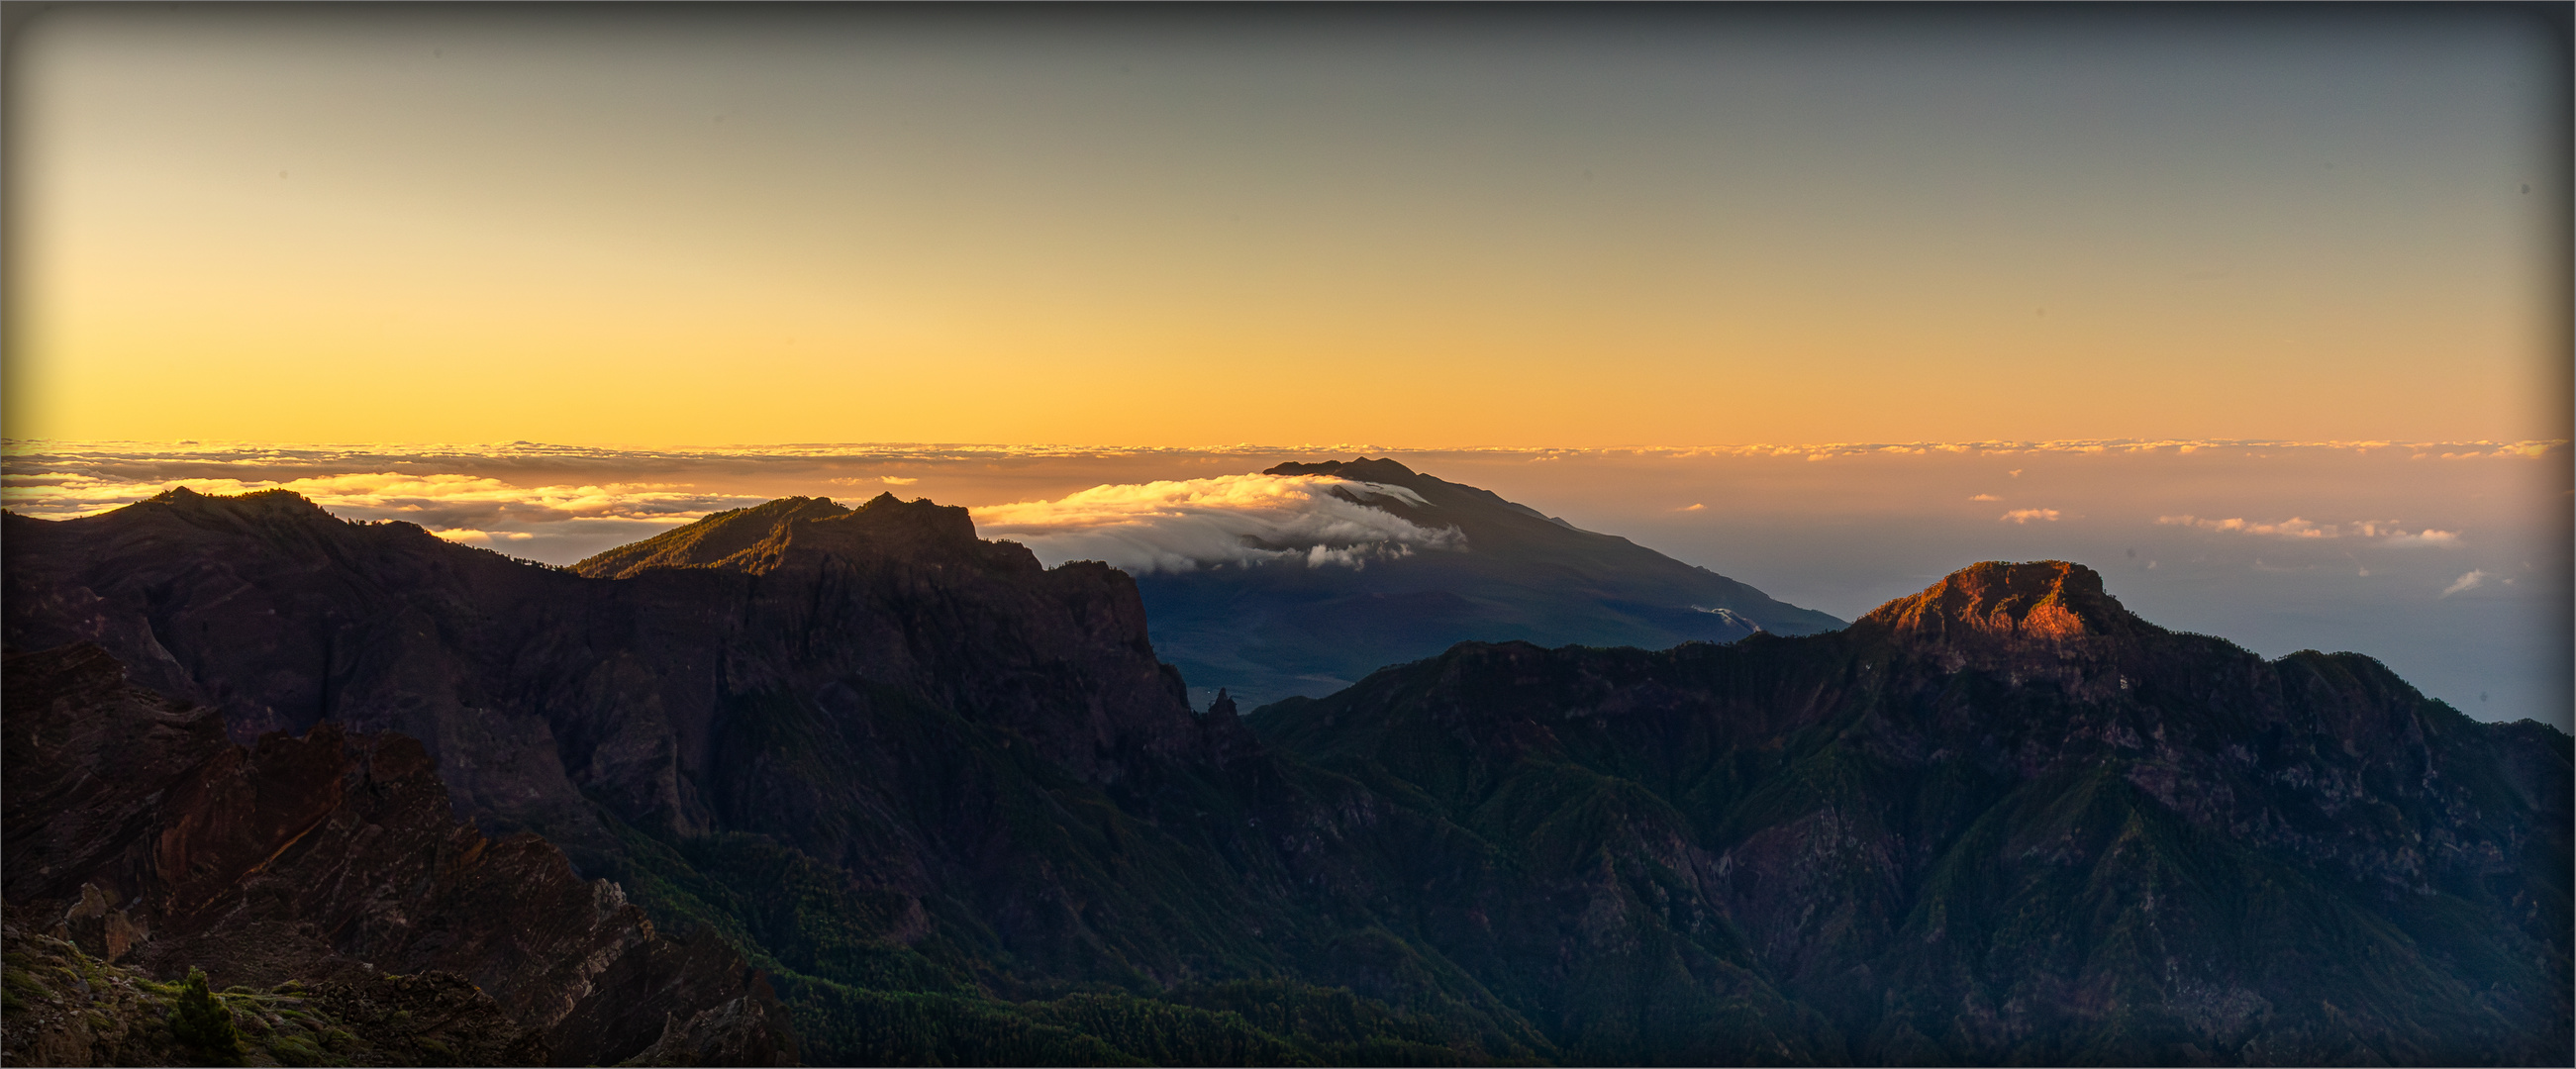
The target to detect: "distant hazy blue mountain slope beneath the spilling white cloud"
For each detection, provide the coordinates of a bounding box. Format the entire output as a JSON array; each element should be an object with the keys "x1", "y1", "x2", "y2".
[{"x1": 1136, "y1": 458, "x2": 1841, "y2": 706}]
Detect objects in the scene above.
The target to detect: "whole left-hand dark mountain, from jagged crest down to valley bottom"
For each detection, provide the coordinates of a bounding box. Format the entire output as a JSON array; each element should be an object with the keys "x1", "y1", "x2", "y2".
[{"x1": 5, "y1": 492, "x2": 1545, "y2": 1061}]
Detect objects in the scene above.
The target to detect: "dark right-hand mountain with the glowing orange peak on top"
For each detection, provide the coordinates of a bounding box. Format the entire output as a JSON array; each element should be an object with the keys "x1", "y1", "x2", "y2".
[{"x1": 1254, "y1": 561, "x2": 2571, "y2": 1064}]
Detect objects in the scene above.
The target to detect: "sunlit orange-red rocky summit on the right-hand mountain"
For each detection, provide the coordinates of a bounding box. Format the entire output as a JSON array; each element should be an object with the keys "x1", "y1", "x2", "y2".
[{"x1": 1854, "y1": 561, "x2": 2153, "y2": 644}]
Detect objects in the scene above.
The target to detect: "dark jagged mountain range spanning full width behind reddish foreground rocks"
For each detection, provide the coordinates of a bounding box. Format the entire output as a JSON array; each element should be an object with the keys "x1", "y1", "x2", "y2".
[{"x1": 0, "y1": 492, "x2": 2571, "y2": 1064}]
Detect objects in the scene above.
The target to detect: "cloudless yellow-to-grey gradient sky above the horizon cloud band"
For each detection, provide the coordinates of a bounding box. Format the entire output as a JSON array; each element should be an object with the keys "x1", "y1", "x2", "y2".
[{"x1": 0, "y1": 5, "x2": 2568, "y2": 448}]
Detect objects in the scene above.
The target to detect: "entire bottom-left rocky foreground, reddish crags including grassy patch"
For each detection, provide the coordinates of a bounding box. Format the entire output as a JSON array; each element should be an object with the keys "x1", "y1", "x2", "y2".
[{"x1": 0, "y1": 644, "x2": 796, "y2": 1066}]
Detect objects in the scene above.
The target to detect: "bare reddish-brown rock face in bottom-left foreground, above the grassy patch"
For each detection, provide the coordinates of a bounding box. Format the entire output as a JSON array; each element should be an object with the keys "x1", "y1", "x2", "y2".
[{"x1": 0, "y1": 644, "x2": 793, "y2": 1064}]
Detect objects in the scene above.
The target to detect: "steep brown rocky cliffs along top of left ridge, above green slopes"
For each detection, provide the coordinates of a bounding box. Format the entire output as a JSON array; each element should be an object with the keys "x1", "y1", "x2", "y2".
[{"x1": 5, "y1": 489, "x2": 1208, "y2": 858}]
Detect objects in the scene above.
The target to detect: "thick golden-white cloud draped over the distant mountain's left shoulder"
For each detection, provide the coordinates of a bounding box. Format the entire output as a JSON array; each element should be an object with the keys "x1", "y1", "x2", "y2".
[{"x1": 974, "y1": 474, "x2": 1466, "y2": 574}]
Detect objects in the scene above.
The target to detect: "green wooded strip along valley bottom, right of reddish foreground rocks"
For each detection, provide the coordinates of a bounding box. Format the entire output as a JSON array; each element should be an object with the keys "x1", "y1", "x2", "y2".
[{"x1": 589, "y1": 798, "x2": 1545, "y2": 1066}]
